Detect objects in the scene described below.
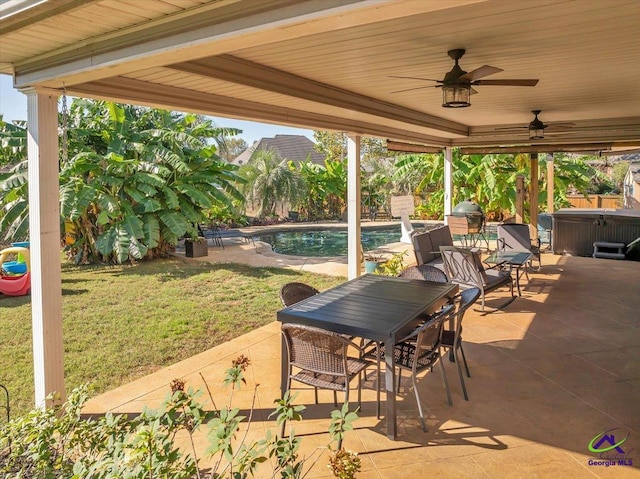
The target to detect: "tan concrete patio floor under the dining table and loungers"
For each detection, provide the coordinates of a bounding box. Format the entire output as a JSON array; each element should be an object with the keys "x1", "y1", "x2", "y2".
[{"x1": 85, "y1": 237, "x2": 640, "y2": 479}]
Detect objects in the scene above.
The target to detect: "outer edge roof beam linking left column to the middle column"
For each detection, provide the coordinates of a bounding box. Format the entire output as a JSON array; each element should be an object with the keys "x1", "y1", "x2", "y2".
[{"x1": 67, "y1": 77, "x2": 448, "y2": 145}]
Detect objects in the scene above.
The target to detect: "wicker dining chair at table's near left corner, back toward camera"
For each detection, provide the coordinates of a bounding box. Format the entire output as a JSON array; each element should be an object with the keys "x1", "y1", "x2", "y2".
[{"x1": 282, "y1": 323, "x2": 373, "y2": 407}]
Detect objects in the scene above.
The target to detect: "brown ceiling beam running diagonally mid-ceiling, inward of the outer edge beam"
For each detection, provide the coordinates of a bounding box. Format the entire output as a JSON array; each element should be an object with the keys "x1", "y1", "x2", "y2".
[{"x1": 168, "y1": 55, "x2": 469, "y2": 137}]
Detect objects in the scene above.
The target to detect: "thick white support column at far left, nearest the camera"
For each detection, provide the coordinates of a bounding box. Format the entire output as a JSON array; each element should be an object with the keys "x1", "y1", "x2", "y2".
[{"x1": 23, "y1": 89, "x2": 66, "y2": 407}]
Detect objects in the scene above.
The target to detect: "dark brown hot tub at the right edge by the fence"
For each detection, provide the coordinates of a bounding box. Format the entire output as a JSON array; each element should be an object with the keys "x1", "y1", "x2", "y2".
[{"x1": 553, "y1": 208, "x2": 640, "y2": 256}]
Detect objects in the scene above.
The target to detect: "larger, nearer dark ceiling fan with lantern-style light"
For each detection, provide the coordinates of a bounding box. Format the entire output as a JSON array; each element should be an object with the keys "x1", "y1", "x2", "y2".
[{"x1": 391, "y1": 48, "x2": 538, "y2": 108}]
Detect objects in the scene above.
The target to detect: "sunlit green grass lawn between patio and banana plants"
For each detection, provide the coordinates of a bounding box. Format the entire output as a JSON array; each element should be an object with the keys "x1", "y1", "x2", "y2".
[{"x1": 0, "y1": 258, "x2": 345, "y2": 417}]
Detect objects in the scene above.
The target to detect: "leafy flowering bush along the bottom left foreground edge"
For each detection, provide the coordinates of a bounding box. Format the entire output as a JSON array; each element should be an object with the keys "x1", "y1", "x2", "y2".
[{"x1": 0, "y1": 356, "x2": 360, "y2": 479}]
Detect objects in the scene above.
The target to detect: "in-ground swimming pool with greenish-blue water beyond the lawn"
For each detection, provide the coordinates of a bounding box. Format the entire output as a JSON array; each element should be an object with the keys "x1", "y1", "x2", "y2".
[{"x1": 254, "y1": 225, "x2": 418, "y2": 256}]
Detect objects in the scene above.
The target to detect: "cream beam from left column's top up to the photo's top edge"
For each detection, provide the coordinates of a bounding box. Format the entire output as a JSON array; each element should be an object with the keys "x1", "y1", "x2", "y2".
[{"x1": 15, "y1": 0, "x2": 424, "y2": 88}]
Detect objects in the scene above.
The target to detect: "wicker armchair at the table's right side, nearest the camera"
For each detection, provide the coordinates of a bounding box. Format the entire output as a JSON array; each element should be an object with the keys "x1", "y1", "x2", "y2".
[{"x1": 364, "y1": 304, "x2": 455, "y2": 432}]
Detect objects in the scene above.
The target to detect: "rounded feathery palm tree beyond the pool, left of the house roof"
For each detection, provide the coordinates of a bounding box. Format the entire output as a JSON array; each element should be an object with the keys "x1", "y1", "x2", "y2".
[{"x1": 239, "y1": 149, "x2": 305, "y2": 218}]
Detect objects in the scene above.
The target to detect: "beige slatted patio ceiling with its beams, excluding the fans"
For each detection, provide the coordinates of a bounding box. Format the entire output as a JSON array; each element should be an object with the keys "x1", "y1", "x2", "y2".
[{"x1": 0, "y1": 0, "x2": 640, "y2": 149}]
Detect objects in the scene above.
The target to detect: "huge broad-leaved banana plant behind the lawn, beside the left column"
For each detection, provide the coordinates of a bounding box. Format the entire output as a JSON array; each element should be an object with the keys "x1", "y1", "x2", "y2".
[{"x1": 0, "y1": 99, "x2": 242, "y2": 263}]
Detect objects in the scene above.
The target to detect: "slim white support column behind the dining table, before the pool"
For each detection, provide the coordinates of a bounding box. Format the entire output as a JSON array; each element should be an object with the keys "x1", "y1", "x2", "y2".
[{"x1": 347, "y1": 135, "x2": 362, "y2": 279}]
